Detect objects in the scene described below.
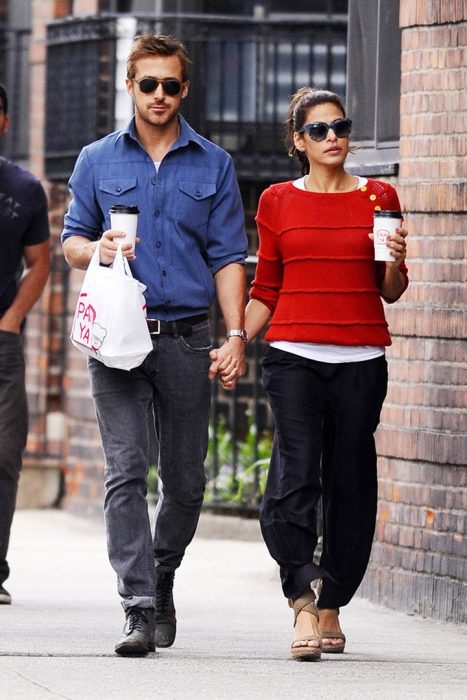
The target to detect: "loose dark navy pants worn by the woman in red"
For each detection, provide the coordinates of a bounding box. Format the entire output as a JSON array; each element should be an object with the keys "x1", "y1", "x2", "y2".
[{"x1": 260, "y1": 348, "x2": 387, "y2": 609}]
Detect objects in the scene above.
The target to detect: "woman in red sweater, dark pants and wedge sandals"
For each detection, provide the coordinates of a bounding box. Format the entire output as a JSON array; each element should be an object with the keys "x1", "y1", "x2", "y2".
[{"x1": 243, "y1": 88, "x2": 408, "y2": 660}]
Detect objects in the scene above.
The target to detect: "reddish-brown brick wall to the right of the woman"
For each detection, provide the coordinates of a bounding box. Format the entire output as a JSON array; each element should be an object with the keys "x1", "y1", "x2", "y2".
[{"x1": 360, "y1": 0, "x2": 467, "y2": 622}]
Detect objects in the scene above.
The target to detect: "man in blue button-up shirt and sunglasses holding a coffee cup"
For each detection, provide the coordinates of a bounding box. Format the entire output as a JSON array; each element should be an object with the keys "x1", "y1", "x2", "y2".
[{"x1": 62, "y1": 34, "x2": 247, "y2": 655}]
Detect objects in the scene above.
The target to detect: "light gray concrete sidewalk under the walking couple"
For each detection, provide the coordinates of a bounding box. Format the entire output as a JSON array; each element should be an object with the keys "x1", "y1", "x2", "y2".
[{"x1": 0, "y1": 510, "x2": 467, "y2": 700}]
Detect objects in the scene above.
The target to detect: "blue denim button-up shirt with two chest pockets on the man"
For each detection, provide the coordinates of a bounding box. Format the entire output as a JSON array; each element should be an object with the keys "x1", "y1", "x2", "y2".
[{"x1": 62, "y1": 116, "x2": 248, "y2": 320}]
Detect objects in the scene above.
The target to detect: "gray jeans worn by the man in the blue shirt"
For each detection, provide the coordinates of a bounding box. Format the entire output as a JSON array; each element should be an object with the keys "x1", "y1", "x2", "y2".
[{"x1": 89, "y1": 321, "x2": 211, "y2": 609}]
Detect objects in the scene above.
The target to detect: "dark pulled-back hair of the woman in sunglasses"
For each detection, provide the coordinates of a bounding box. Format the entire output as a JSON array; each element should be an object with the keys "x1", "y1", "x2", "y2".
[{"x1": 284, "y1": 87, "x2": 346, "y2": 175}]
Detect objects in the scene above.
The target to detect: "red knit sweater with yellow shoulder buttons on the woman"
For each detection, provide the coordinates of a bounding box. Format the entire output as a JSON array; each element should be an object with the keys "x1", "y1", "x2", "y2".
[{"x1": 250, "y1": 180, "x2": 408, "y2": 345}]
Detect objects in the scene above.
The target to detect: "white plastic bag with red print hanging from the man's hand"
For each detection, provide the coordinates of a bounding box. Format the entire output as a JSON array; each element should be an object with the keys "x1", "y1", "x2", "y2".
[{"x1": 70, "y1": 245, "x2": 152, "y2": 370}]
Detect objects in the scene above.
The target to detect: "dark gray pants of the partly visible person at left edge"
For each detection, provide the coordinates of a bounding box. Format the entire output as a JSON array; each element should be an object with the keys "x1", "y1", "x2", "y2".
[{"x1": 0, "y1": 331, "x2": 28, "y2": 585}]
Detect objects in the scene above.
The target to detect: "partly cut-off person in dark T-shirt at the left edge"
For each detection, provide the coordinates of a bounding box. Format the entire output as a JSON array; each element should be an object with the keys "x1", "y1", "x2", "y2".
[{"x1": 0, "y1": 84, "x2": 49, "y2": 605}]
